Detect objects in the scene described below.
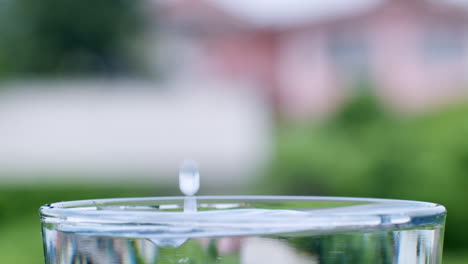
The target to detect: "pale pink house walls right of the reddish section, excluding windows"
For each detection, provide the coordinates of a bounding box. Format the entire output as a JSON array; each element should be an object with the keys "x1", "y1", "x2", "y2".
[{"x1": 278, "y1": 1, "x2": 468, "y2": 117}]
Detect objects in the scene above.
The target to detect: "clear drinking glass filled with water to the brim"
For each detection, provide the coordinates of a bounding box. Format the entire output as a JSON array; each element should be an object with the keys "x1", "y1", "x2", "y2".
[{"x1": 40, "y1": 196, "x2": 446, "y2": 264}]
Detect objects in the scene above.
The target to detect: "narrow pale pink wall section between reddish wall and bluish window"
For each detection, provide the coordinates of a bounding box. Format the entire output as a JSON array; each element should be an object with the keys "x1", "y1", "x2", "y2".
[{"x1": 278, "y1": 30, "x2": 340, "y2": 116}]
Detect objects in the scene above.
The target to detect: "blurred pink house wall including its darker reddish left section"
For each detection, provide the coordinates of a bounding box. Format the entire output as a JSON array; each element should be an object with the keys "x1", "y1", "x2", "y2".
[{"x1": 161, "y1": 0, "x2": 468, "y2": 117}]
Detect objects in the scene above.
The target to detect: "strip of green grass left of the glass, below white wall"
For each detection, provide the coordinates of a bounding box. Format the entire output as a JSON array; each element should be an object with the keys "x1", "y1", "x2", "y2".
[{"x1": 0, "y1": 185, "x2": 168, "y2": 264}]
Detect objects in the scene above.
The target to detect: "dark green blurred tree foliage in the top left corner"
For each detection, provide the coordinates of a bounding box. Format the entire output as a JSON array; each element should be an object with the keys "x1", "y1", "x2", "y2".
[{"x1": 0, "y1": 0, "x2": 142, "y2": 77}]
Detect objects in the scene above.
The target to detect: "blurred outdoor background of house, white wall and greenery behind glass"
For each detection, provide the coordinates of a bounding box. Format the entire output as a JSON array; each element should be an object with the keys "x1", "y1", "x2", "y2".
[{"x1": 0, "y1": 0, "x2": 468, "y2": 264}]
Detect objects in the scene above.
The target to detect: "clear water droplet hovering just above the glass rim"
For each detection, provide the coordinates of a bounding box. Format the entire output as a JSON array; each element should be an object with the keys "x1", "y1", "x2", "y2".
[{"x1": 179, "y1": 160, "x2": 200, "y2": 195}]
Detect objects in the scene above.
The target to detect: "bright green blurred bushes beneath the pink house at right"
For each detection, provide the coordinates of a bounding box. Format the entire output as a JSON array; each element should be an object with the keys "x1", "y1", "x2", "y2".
[{"x1": 264, "y1": 95, "x2": 468, "y2": 251}]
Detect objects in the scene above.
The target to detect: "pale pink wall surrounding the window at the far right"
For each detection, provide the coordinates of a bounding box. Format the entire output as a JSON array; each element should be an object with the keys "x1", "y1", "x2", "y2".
[{"x1": 371, "y1": 2, "x2": 468, "y2": 109}]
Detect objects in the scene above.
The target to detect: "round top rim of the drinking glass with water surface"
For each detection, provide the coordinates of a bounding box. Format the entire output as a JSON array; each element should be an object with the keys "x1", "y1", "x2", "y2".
[{"x1": 40, "y1": 195, "x2": 446, "y2": 237}]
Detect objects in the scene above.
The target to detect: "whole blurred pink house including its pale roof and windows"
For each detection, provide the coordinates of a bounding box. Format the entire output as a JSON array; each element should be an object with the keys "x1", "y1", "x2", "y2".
[{"x1": 155, "y1": 0, "x2": 468, "y2": 117}]
